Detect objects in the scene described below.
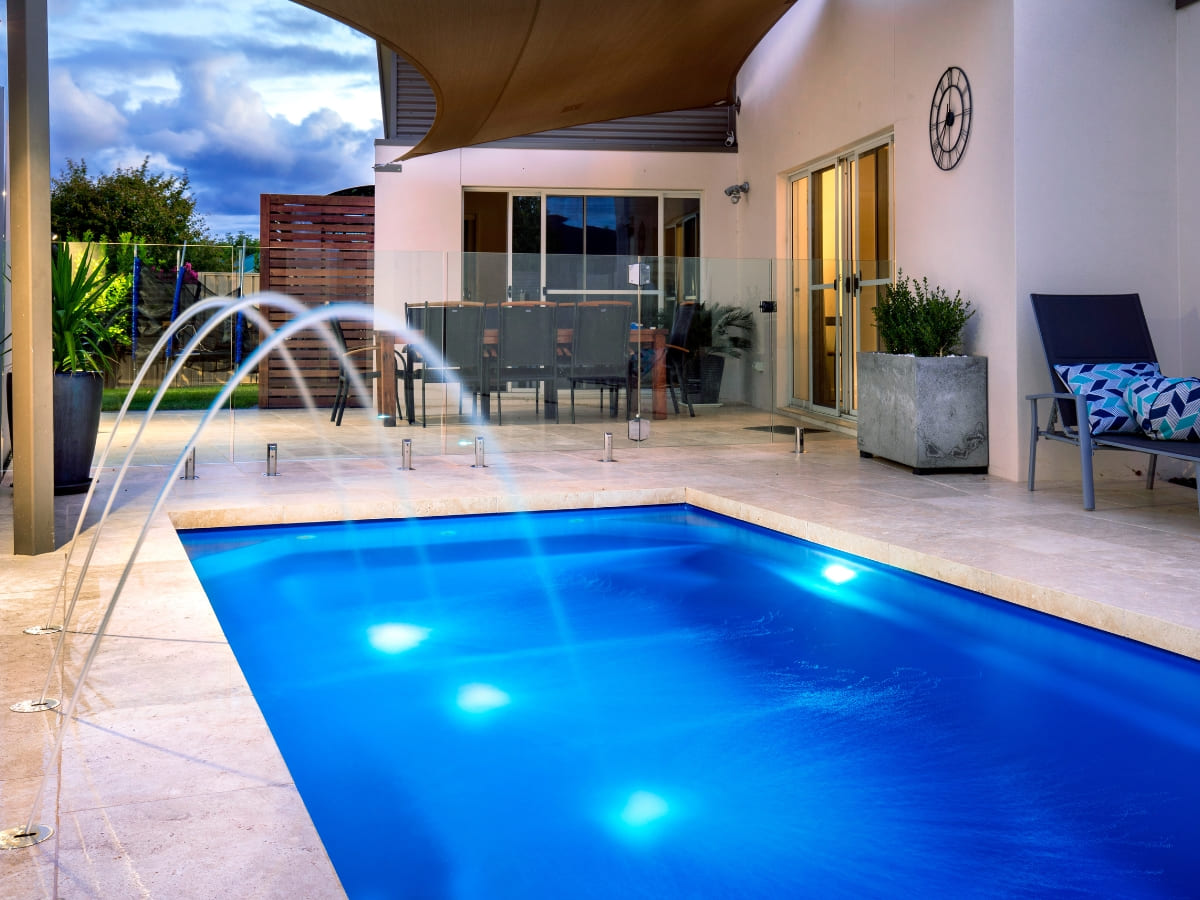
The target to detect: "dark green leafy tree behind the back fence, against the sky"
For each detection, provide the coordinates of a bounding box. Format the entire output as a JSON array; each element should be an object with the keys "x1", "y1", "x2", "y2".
[{"x1": 50, "y1": 156, "x2": 208, "y2": 244}]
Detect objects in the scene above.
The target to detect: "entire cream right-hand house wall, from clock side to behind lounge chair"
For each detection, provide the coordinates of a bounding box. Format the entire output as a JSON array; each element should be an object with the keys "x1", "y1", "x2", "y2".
[{"x1": 737, "y1": 0, "x2": 1200, "y2": 487}]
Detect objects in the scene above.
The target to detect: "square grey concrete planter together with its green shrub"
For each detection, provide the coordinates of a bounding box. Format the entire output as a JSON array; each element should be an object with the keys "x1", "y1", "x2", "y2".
[{"x1": 858, "y1": 270, "x2": 988, "y2": 474}]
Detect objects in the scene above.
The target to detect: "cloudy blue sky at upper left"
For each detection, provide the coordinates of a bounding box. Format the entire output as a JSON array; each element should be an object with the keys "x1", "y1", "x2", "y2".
[{"x1": 2, "y1": 0, "x2": 383, "y2": 236}]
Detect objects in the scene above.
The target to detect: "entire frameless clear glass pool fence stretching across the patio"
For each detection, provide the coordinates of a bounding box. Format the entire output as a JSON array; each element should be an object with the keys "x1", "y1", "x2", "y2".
[{"x1": 32, "y1": 245, "x2": 890, "y2": 469}]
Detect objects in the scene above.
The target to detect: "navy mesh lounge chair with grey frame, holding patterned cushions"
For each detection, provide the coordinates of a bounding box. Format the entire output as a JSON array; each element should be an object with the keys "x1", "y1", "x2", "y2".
[{"x1": 1026, "y1": 294, "x2": 1200, "y2": 510}]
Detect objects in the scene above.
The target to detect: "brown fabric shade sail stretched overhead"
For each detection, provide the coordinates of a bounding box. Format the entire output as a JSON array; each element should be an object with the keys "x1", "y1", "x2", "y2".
[{"x1": 296, "y1": 0, "x2": 793, "y2": 157}]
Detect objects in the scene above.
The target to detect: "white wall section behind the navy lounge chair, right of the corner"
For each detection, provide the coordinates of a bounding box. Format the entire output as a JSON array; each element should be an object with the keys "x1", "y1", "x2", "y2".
[{"x1": 1014, "y1": 0, "x2": 1180, "y2": 487}]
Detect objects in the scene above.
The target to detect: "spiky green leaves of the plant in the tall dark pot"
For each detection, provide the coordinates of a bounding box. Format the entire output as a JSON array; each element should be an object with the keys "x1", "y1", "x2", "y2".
[{"x1": 50, "y1": 245, "x2": 127, "y2": 376}]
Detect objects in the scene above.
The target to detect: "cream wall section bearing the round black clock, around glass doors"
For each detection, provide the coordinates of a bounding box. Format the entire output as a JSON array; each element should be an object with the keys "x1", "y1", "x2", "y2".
[{"x1": 738, "y1": 0, "x2": 1024, "y2": 478}]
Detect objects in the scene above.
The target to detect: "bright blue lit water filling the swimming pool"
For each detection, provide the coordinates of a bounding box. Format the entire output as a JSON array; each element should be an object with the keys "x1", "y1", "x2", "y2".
[{"x1": 182, "y1": 506, "x2": 1200, "y2": 900}]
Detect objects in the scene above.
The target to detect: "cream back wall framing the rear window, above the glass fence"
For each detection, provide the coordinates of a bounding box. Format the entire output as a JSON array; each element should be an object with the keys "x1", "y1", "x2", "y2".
[{"x1": 376, "y1": 143, "x2": 738, "y2": 328}]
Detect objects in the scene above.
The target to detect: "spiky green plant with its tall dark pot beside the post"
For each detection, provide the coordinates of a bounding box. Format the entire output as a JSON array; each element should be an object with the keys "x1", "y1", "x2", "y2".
[{"x1": 50, "y1": 245, "x2": 128, "y2": 494}]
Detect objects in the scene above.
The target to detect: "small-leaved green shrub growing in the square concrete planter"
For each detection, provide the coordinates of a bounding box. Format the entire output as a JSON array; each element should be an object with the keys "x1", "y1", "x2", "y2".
[{"x1": 875, "y1": 269, "x2": 974, "y2": 356}]
